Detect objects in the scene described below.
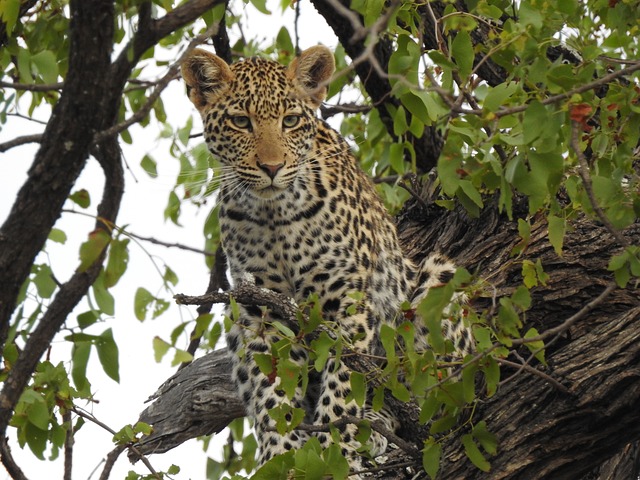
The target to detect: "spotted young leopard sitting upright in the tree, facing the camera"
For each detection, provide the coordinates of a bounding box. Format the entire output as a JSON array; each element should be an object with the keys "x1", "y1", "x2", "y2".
[{"x1": 181, "y1": 45, "x2": 471, "y2": 470}]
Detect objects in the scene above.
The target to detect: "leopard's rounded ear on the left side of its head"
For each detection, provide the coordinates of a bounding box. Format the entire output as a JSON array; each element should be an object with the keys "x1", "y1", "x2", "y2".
[{"x1": 180, "y1": 48, "x2": 233, "y2": 110}]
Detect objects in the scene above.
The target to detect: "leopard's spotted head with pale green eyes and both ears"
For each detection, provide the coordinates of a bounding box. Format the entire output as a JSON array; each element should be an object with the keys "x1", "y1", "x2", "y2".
[{"x1": 182, "y1": 46, "x2": 335, "y2": 199}]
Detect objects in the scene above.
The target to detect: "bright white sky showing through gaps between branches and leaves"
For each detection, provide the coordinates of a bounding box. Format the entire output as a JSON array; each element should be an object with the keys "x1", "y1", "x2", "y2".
[{"x1": 0, "y1": 0, "x2": 336, "y2": 480}]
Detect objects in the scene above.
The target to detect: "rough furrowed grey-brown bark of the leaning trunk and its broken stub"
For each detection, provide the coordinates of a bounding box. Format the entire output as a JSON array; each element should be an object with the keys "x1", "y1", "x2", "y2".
[{"x1": 132, "y1": 188, "x2": 640, "y2": 479}]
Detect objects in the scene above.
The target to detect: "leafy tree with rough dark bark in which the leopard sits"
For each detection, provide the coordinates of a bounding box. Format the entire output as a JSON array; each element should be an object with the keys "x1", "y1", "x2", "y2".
[{"x1": 0, "y1": 0, "x2": 640, "y2": 479}]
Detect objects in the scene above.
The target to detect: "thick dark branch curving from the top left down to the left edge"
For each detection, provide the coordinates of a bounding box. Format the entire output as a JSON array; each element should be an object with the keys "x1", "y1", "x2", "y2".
[{"x1": 0, "y1": 0, "x2": 114, "y2": 344}]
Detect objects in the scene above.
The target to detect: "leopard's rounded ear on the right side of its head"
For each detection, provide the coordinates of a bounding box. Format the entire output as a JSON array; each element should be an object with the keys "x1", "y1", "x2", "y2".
[{"x1": 287, "y1": 45, "x2": 336, "y2": 107}]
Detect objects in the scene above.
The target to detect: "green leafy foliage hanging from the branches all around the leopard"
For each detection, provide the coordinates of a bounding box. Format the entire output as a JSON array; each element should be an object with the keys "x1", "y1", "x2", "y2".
[{"x1": 0, "y1": 0, "x2": 640, "y2": 478}]
